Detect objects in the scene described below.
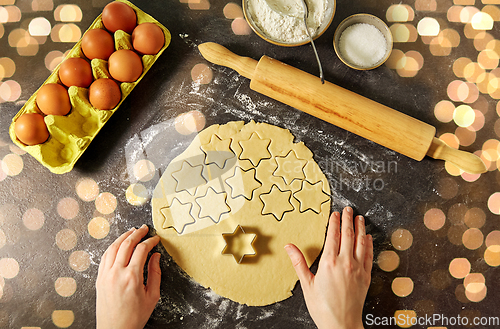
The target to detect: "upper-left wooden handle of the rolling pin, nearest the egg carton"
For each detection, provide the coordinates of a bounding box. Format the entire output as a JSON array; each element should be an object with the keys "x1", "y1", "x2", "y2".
[{"x1": 198, "y1": 42, "x2": 258, "y2": 79}]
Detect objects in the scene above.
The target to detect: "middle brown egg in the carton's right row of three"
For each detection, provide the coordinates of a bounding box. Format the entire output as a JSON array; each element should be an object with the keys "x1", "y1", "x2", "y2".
[{"x1": 108, "y1": 49, "x2": 142, "y2": 82}]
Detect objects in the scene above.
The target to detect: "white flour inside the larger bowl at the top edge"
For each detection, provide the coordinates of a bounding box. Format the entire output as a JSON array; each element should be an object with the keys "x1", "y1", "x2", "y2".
[{"x1": 248, "y1": 0, "x2": 326, "y2": 42}]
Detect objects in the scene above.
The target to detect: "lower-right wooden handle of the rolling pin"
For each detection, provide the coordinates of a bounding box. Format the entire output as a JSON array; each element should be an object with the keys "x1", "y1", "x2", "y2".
[{"x1": 427, "y1": 137, "x2": 488, "y2": 174}]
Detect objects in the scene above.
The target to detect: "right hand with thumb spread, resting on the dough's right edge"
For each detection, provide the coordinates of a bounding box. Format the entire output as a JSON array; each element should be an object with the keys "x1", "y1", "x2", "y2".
[{"x1": 285, "y1": 207, "x2": 373, "y2": 329}]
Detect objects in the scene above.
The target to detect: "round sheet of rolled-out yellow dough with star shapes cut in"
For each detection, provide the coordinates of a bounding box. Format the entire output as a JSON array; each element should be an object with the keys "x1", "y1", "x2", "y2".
[{"x1": 152, "y1": 121, "x2": 330, "y2": 306}]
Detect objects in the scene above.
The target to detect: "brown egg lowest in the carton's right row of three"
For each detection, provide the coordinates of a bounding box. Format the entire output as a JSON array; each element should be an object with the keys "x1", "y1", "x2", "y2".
[{"x1": 89, "y1": 79, "x2": 122, "y2": 110}]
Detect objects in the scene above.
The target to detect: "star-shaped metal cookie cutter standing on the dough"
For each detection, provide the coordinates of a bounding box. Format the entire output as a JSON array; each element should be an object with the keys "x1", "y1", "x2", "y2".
[{"x1": 222, "y1": 225, "x2": 257, "y2": 264}]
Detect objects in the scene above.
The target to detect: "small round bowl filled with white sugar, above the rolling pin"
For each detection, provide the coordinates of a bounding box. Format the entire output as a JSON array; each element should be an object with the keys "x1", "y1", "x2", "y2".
[{"x1": 333, "y1": 14, "x2": 392, "y2": 70}]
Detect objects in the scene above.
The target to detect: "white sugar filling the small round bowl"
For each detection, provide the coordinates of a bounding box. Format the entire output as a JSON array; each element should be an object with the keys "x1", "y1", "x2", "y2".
[{"x1": 339, "y1": 23, "x2": 387, "y2": 67}]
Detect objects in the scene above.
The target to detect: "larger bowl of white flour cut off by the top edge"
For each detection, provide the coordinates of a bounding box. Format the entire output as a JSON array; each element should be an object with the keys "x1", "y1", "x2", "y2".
[{"x1": 243, "y1": 0, "x2": 336, "y2": 47}]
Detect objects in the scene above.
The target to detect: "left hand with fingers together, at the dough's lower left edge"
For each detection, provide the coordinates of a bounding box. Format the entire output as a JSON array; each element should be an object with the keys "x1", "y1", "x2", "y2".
[{"x1": 96, "y1": 225, "x2": 161, "y2": 329}]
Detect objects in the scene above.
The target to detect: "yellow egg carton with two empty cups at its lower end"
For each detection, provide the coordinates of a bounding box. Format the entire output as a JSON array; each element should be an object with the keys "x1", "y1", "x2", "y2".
[{"x1": 9, "y1": 0, "x2": 171, "y2": 174}]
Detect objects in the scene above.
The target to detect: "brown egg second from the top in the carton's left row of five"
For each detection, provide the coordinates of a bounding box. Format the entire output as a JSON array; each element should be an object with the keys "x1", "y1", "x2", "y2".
[{"x1": 82, "y1": 29, "x2": 115, "y2": 60}]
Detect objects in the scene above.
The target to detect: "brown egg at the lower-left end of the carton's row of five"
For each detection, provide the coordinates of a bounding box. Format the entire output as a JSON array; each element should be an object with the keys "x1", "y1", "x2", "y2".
[{"x1": 14, "y1": 113, "x2": 49, "y2": 145}]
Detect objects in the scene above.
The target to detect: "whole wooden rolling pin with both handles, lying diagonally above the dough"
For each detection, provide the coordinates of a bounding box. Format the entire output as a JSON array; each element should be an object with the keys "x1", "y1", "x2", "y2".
[{"x1": 198, "y1": 42, "x2": 487, "y2": 174}]
